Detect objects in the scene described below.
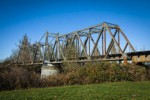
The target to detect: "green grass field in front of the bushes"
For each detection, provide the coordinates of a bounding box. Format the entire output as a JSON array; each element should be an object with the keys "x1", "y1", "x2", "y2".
[{"x1": 0, "y1": 81, "x2": 150, "y2": 100}]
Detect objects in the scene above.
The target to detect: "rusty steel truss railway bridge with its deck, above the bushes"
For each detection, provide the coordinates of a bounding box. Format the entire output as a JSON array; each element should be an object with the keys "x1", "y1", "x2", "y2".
[{"x1": 18, "y1": 22, "x2": 150, "y2": 64}]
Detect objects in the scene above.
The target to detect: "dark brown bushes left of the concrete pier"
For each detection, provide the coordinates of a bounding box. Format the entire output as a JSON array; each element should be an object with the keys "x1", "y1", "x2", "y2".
[{"x1": 0, "y1": 67, "x2": 41, "y2": 90}]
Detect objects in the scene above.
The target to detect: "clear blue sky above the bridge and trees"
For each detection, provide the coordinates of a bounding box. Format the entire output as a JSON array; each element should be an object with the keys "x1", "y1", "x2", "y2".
[{"x1": 0, "y1": 0, "x2": 150, "y2": 59}]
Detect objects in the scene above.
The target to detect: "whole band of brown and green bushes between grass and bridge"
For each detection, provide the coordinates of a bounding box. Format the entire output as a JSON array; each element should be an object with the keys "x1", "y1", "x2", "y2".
[{"x1": 0, "y1": 62, "x2": 147, "y2": 90}]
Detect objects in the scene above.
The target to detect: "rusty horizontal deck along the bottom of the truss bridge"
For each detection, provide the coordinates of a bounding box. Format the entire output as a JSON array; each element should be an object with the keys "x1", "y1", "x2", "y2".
[{"x1": 47, "y1": 51, "x2": 150, "y2": 64}]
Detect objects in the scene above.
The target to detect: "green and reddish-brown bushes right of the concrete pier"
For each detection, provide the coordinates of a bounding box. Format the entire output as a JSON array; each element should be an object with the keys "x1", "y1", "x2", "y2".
[{"x1": 60, "y1": 62, "x2": 147, "y2": 84}]
